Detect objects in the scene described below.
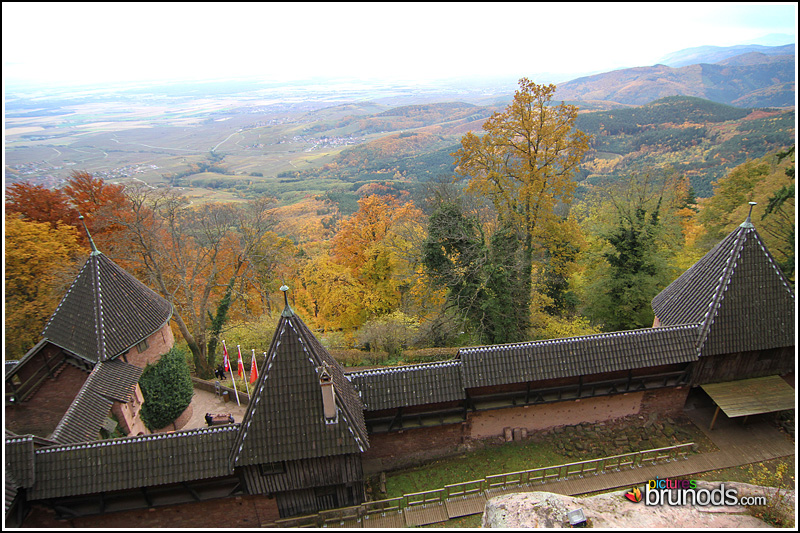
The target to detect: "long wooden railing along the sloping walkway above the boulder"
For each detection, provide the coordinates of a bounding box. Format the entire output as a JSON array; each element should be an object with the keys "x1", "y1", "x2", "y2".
[{"x1": 274, "y1": 442, "x2": 694, "y2": 527}]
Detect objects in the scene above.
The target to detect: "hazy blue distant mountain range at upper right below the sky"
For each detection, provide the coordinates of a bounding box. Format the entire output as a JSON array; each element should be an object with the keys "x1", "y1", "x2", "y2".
[{"x1": 556, "y1": 44, "x2": 795, "y2": 108}]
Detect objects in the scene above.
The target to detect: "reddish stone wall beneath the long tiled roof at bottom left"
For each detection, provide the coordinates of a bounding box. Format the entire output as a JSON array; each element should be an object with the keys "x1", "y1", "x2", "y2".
[{"x1": 22, "y1": 495, "x2": 280, "y2": 530}]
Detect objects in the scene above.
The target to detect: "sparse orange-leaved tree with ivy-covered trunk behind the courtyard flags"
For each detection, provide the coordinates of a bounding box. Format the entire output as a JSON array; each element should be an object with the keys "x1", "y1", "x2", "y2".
[{"x1": 101, "y1": 187, "x2": 291, "y2": 377}]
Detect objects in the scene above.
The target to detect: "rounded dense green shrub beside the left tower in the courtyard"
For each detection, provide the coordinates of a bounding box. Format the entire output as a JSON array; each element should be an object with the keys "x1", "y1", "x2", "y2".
[{"x1": 139, "y1": 348, "x2": 194, "y2": 431}]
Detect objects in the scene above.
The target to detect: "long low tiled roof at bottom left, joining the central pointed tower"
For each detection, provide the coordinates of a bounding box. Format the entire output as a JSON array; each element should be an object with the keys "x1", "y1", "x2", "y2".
[{"x1": 23, "y1": 424, "x2": 239, "y2": 500}]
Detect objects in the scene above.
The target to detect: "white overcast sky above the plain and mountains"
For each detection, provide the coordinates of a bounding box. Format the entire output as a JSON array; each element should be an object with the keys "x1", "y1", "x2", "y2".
[{"x1": 3, "y1": 2, "x2": 797, "y2": 85}]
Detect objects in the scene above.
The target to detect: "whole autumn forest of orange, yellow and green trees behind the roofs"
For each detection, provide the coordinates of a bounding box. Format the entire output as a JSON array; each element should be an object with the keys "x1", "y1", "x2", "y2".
[{"x1": 5, "y1": 78, "x2": 795, "y2": 378}]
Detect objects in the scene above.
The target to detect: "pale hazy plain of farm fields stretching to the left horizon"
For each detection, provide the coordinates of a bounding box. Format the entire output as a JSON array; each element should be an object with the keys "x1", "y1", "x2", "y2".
[{"x1": 4, "y1": 77, "x2": 507, "y2": 197}]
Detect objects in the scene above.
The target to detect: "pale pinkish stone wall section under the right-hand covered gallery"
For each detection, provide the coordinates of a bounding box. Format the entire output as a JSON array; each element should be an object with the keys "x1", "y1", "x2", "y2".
[{"x1": 468, "y1": 392, "x2": 644, "y2": 439}]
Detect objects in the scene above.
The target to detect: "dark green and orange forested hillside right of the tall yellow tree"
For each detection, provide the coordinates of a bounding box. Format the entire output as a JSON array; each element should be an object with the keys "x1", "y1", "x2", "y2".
[{"x1": 577, "y1": 96, "x2": 795, "y2": 197}]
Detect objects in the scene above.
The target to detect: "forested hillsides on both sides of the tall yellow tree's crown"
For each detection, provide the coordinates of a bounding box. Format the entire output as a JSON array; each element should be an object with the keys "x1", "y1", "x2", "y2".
[{"x1": 238, "y1": 96, "x2": 795, "y2": 215}]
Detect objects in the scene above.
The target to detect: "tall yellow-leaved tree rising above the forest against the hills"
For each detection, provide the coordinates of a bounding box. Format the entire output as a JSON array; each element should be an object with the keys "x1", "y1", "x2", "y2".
[{"x1": 453, "y1": 78, "x2": 590, "y2": 342}]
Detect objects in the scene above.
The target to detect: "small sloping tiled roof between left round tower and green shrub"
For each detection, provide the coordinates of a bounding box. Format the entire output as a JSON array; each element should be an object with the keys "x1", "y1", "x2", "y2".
[{"x1": 50, "y1": 360, "x2": 143, "y2": 444}]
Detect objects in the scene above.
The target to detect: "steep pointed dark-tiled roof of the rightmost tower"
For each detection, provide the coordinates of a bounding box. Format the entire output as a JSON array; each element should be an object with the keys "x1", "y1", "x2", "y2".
[{"x1": 652, "y1": 217, "x2": 795, "y2": 355}]
